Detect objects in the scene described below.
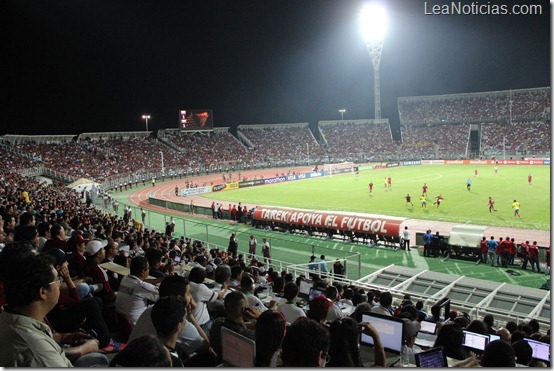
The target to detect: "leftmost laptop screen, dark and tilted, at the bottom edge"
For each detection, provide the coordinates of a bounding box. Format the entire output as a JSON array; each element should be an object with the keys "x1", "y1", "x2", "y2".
[{"x1": 221, "y1": 327, "x2": 256, "y2": 368}]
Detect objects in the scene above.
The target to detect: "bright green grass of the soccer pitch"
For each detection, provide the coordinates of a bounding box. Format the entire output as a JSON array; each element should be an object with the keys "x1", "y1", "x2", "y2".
[{"x1": 198, "y1": 165, "x2": 550, "y2": 230}]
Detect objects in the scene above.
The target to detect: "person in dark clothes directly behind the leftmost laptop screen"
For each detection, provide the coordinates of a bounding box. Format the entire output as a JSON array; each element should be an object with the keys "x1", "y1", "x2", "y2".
[{"x1": 210, "y1": 291, "x2": 261, "y2": 364}]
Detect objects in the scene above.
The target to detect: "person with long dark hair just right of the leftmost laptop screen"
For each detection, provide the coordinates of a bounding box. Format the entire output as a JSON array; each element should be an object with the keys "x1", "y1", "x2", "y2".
[{"x1": 255, "y1": 310, "x2": 287, "y2": 367}]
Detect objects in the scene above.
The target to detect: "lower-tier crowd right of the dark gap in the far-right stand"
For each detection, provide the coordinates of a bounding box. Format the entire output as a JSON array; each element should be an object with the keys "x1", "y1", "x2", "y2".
[{"x1": 481, "y1": 121, "x2": 551, "y2": 154}]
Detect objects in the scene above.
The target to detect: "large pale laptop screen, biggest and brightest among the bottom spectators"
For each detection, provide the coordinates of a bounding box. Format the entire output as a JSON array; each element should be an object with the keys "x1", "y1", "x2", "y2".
[{"x1": 360, "y1": 312, "x2": 403, "y2": 354}]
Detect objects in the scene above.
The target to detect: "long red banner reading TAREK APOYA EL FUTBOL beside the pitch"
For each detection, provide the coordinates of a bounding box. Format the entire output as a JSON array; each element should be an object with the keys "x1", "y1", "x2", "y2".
[{"x1": 254, "y1": 208, "x2": 405, "y2": 237}]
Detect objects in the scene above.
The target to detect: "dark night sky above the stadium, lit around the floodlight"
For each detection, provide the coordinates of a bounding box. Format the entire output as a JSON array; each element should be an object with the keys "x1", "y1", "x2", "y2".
[{"x1": 0, "y1": 0, "x2": 551, "y2": 134}]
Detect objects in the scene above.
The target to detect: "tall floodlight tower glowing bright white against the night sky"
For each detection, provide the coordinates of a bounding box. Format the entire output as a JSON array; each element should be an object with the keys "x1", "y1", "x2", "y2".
[{"x1": 362, "y1": 3, "x2": 387, "y2": 119}]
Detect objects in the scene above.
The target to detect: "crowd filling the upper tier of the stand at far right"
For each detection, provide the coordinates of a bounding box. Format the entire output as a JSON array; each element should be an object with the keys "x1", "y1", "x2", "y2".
[{"x1": 398, "y1": 88, "x2": 551, "y2": 125}]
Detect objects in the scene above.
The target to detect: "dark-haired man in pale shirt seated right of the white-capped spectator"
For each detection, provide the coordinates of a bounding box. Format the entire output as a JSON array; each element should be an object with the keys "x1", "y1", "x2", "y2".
[{"x1": 115, "y1": 256, "x2": 159, "y2": 325}]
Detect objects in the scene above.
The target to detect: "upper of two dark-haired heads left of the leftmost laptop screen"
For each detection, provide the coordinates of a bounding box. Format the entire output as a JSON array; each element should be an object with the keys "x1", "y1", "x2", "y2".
[{"x1": 151, "y1": 296, "x2": 187, "y2": 367}]
